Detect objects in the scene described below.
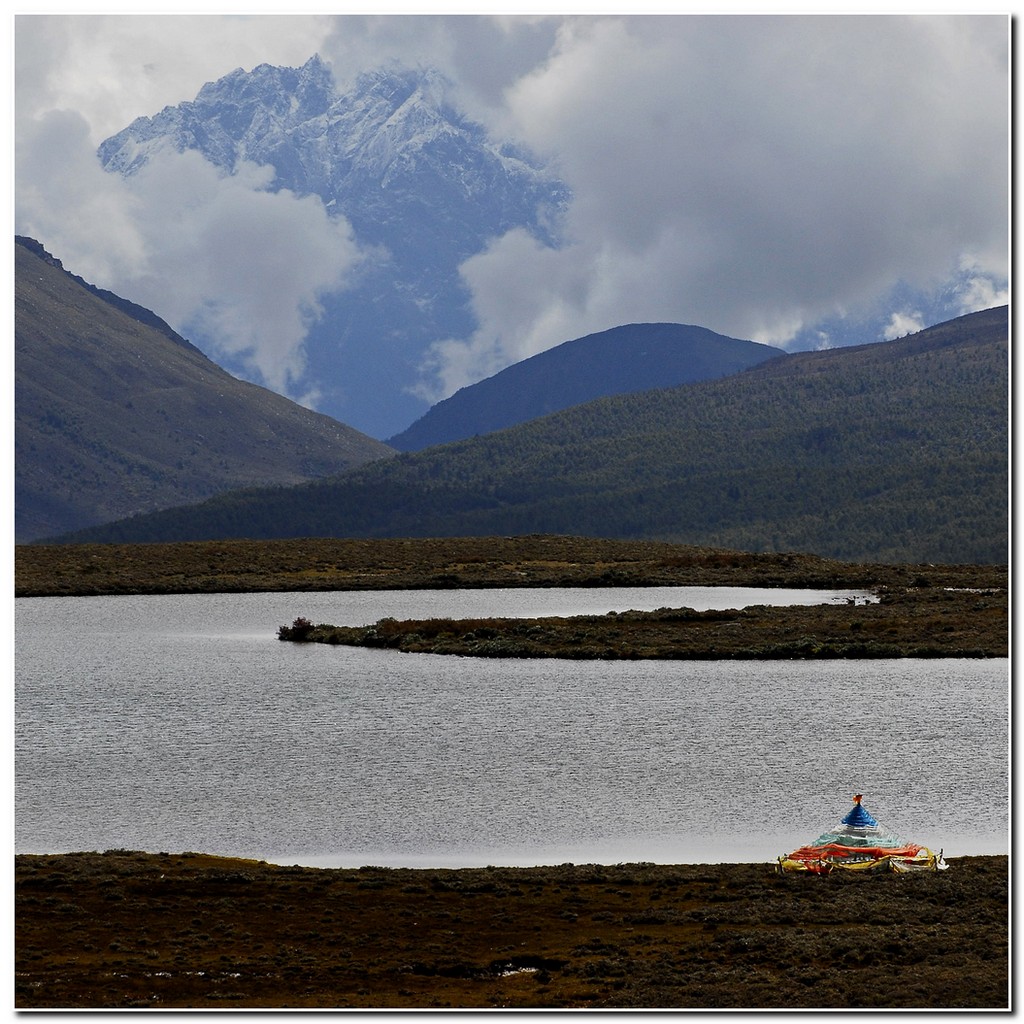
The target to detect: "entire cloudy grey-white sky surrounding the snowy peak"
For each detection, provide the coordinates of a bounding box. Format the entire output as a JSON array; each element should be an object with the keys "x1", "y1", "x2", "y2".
[{"x1": 14, "y1": 14, "x2": 1010, "y2": 403}]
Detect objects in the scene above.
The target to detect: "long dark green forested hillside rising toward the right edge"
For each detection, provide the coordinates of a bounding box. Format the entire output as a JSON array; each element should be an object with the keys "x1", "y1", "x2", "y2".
[{"x1": 51, "y1": 307, "x2": 1009, "y2": 563}]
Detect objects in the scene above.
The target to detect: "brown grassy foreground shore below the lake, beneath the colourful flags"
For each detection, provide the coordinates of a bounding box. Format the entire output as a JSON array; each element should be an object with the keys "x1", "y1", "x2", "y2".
[{"x1": 14, "y1": 851, "x2": 1009, "y2": 1010}]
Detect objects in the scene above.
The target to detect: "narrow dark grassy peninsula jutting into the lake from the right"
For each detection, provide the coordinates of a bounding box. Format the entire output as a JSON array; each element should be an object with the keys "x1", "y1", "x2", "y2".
[{"x1": 278, "y1": 587, "x2": 1009, "y2": 659}]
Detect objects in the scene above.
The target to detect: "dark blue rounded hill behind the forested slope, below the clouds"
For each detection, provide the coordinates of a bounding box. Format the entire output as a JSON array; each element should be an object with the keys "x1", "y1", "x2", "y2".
[{"x1": 388, "y1": 324, "x2": 785, "y2": 452}]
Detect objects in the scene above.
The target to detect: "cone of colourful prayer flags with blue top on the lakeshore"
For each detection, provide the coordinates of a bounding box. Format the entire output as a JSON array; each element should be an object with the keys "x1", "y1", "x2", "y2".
[{"x1": 778, "y1": 794, "x2": 948, "y2": 874}]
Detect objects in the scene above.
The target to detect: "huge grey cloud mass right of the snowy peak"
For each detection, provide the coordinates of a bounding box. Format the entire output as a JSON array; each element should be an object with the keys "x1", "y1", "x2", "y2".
[{"x1": 415, "y1": 16, "x2": 1009, "y2": 394}]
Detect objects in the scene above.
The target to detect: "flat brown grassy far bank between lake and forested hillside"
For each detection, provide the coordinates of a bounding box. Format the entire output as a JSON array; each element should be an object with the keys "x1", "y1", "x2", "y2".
[{"x1": 14, "y1": 535, "x2": 1009, "y2": 597}]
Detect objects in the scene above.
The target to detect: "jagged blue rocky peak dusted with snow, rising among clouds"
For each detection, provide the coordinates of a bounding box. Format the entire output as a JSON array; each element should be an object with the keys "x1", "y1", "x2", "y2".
[{"x1": 99, "y1": 56, "x2": 570, "y2": 437}]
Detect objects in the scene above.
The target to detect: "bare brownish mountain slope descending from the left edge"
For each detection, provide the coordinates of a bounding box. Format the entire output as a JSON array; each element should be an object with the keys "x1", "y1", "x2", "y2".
[{"x1": 14, "y1": 239, "x2": 394, "y2": 542}]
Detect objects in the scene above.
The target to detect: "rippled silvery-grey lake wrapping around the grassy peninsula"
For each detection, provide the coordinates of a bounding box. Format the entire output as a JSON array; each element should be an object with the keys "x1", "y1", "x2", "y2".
[{"x1": 15, "y1": 588, "x2": 1010, "y2": 866}]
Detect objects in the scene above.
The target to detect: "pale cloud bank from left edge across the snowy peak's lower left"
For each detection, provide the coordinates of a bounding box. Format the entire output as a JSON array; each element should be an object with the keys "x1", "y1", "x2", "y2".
[{"x1": 15, "y1": 101, "x2": 360, "y2": 395}]
